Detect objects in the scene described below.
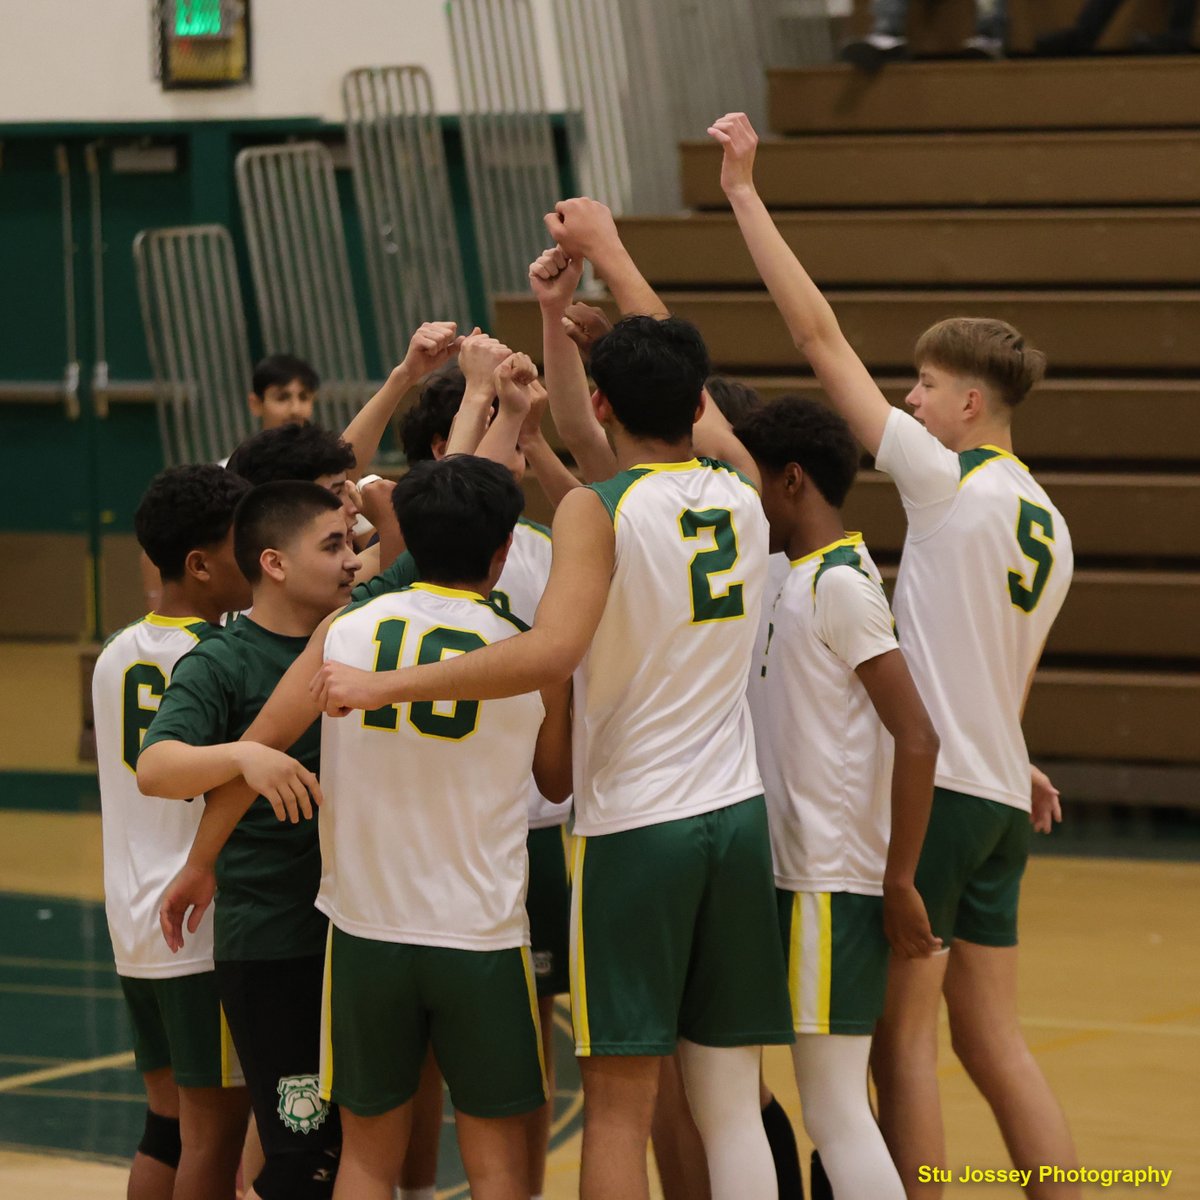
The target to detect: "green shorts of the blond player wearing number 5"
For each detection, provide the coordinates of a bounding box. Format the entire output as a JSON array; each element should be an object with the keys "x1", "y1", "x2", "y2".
[{"x1": 917, "y1": 787, "x2": 1032, "y2": 946}]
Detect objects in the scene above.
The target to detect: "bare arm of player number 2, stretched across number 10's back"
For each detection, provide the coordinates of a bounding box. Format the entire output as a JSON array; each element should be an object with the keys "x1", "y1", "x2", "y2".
[{"x1": 312, "y1": 488, "x2": 616, "y2": 716}]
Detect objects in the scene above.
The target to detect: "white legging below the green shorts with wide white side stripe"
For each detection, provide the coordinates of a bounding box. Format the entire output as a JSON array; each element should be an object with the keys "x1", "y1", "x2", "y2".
[{"x1": 792, "y1": 1033, "x2": 905, "y2": 1200}]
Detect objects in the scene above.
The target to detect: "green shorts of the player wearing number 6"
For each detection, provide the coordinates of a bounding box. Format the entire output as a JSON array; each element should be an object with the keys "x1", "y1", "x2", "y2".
[{"x1": 119, "y1": 971, "x2": 244, "y2": 1087}]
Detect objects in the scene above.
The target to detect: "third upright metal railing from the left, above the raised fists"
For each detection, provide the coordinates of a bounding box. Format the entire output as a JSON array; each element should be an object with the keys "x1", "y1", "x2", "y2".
[{"x1": 342, "y1": 66, "x2": 470, "y2": 364}]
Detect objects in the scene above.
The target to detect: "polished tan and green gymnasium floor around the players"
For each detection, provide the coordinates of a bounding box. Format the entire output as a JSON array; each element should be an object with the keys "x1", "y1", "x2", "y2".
[{"x1": 0, "y1": 644, "x2": 1200, "y2": 1200}]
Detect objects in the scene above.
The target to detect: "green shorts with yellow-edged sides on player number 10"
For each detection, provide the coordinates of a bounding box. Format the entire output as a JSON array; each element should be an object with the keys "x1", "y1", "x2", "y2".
[{"x1": 320, "y1": 926, "x2": 546, "y2": 1117}]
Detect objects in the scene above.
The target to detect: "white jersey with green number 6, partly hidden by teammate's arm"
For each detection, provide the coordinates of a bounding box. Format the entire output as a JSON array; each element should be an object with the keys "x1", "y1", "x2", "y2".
[{"x1": 91, "y1": 613, "x2": 217, "y2": 979}]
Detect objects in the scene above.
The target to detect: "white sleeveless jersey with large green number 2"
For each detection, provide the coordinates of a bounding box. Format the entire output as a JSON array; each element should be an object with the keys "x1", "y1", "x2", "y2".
[{"x1": 574, "y1": 458, "x2": 767, "y2": 835}]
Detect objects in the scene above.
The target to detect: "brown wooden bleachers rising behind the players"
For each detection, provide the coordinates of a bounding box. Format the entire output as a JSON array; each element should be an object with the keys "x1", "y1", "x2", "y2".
[{"x1": 496, "y1": 49, "x2": 1200, "y2": 804}]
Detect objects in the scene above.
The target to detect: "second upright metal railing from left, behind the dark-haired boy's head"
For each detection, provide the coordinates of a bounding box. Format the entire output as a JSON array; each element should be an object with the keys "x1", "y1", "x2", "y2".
[{"x1": 234, "y1": 142, "x2": 374, "y2": 430}]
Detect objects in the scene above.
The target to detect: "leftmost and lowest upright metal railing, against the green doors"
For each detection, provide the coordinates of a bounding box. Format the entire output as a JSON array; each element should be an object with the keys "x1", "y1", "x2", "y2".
[{"x1": 133, "y1": 226, "x2": 252, "y2": 466}]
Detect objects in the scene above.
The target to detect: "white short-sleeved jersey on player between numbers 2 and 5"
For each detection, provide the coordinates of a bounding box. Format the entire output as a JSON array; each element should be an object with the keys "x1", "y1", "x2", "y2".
[{"x1": 750, "y1": 533, "x2": 899, "y2": 895}]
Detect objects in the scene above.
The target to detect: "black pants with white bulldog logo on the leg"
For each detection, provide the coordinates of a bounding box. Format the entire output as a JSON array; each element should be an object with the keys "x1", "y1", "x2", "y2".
[{"x1": 216, "y1": 954, "x2": 342, "y2": 1200}]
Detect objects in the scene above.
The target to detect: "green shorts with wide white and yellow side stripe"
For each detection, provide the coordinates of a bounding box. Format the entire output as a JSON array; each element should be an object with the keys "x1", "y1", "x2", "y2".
[{"x1": 775, "y1": 889, "x2": 890, "y2": 1036}]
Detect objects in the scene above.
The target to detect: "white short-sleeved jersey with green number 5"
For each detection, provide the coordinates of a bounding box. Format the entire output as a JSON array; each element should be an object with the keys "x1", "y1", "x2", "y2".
[{"x1": 876, "y1": 409, "x2": 1074, "y2": 811}]
